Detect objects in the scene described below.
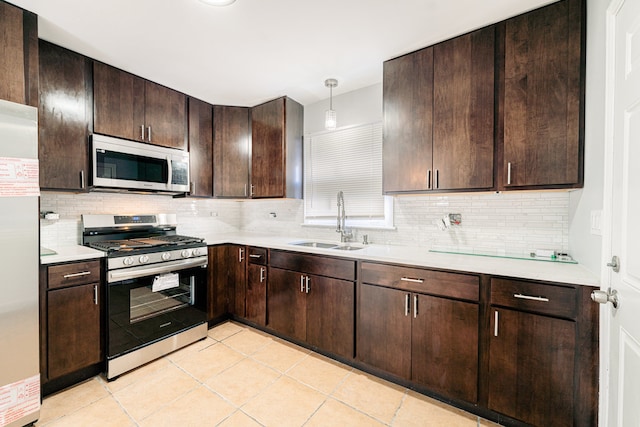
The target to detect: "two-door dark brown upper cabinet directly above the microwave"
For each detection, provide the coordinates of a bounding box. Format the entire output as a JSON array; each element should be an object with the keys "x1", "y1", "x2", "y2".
[{"x1": 93, "y1": 62, "x2": 187, "y2": 150}]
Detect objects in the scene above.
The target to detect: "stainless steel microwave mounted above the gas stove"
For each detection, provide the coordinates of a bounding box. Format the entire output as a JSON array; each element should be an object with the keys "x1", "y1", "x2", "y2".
[{"x1": 91, "y1": 134, "x2": 189, "y2": 194}]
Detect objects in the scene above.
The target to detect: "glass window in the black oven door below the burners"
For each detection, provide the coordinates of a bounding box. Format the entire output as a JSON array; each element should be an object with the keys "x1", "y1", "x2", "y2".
[{"x1": 129, "y1": 275, "x2": 195, "y2": 323}]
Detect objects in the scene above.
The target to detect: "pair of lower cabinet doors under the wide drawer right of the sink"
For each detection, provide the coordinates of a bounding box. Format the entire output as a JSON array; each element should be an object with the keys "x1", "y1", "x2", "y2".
[{"x1": 357, "y1": 284, "x2": 479, "y2": 402}]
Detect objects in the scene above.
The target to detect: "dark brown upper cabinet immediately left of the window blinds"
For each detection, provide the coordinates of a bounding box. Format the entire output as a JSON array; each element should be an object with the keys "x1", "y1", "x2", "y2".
[{"x1": 251, "y1": 97, "x2": 304, "y2": 199}]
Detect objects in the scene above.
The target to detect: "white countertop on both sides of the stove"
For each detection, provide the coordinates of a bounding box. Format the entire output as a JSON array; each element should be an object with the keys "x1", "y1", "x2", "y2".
[{"x1": 40, "y1": 232, "x2": 600, "y2": 286}]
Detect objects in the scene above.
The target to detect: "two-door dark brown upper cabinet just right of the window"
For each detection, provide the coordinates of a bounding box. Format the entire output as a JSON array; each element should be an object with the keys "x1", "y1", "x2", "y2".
[{"x1": 383, "y1": 26, "x2": 495, "y2": 193}]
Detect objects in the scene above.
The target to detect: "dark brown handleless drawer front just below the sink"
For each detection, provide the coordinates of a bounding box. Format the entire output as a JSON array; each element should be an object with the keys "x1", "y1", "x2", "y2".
[{"x1": 269, "y1": 250, "x2": 356, "y2": 280}]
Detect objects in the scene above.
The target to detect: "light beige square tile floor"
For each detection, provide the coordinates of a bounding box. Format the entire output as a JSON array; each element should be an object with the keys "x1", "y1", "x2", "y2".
[{"x1": 36, "y1": 322, "x2": 497, "y2": 427}]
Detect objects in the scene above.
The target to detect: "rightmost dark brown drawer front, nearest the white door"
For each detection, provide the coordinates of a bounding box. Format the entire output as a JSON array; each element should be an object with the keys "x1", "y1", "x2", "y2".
[{"x1": 491, "y1": 279, "x2": 577, "y2": 318}]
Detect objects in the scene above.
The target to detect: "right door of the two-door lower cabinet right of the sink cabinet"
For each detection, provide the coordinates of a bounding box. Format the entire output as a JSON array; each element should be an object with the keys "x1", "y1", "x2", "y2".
[{"x1": 411, "y1": 294, "x2": 479, "y2": 403}]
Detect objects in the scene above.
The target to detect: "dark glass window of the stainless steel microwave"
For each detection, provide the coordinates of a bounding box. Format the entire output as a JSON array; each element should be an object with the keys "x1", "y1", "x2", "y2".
[{"x1": 96, "y1": 150, "x2": 169, "y2": 183}]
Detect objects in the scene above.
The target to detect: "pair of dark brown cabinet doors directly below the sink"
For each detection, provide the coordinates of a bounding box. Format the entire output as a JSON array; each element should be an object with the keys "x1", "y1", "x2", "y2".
[{"x1": 267, "y1": 267, "x2": 355, "y2": 358}]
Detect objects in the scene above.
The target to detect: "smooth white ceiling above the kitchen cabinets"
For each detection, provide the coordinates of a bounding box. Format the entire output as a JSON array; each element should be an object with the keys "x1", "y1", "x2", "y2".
[{"x1": 9, "y1": 0, "x2": 553, "y2": 106}]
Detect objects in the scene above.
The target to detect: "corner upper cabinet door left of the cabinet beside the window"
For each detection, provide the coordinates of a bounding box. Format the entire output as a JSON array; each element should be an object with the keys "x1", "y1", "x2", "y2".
[{"x1": 213, "y1": 105, "x2": 251, "y2": 197}]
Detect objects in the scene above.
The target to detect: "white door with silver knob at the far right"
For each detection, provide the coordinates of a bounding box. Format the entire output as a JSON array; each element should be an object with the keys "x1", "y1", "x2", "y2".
[{"x1": 601, "y1": 0, "x2": 640, "y2": 427}]
